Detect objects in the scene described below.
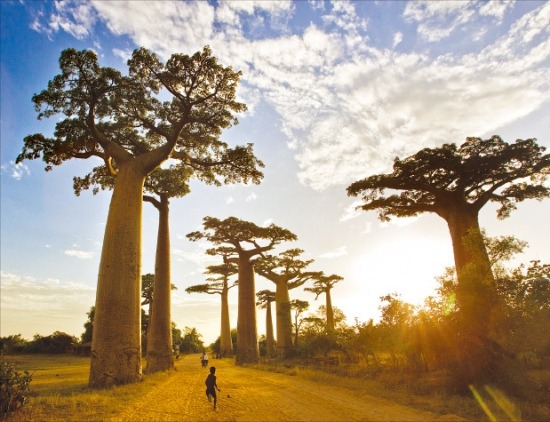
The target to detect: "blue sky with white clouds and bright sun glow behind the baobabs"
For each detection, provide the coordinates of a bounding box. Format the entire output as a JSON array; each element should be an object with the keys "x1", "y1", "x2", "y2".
[{"x1": 0, "y1": 0, "x2": 550, "y2": 344}]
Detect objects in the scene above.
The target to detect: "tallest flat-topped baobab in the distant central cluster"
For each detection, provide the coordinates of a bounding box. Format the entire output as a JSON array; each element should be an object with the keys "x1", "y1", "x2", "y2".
[{"x1": 187, "y1": 217, "x2": 296, "y2": 365}]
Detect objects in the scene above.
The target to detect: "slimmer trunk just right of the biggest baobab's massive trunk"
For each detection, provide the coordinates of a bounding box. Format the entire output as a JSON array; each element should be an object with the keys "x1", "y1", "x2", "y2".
[{"x1": 147, "y1": 198, "x2": 174, "y2": 373}]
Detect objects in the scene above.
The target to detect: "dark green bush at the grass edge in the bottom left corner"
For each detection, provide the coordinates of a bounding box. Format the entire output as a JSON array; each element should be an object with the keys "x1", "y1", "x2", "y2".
[{"x1": 0, "y1": 359, "x2": 32, "y2": 419}]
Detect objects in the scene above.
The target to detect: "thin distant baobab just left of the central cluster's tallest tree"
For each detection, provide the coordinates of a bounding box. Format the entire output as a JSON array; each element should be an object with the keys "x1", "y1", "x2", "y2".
[{"x1": 185, "y1": 262, "x2": 238, "y2": 357}]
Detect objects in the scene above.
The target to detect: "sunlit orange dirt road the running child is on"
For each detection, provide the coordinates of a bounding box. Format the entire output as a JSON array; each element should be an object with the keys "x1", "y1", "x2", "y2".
[{"x1": 112, "y1": 355, "x2": 461, "y2": 422}]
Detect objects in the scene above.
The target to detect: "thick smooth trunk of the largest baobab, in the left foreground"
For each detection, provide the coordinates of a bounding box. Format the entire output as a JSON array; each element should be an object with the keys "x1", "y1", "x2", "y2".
[{"x1": 89, "y1": 165, "x2": 145, "y2": 388}]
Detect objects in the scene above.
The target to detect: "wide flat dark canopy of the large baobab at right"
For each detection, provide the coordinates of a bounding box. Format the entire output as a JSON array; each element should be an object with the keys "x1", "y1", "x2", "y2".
[{"x1": 347, "y1": 136, "x2": 550, "y2": 221}]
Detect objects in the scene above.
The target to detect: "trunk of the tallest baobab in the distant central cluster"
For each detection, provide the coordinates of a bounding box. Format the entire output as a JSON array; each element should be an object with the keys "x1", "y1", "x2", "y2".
[{"x1": 236, "y1": 256, "x2": 260, "y2": 365}]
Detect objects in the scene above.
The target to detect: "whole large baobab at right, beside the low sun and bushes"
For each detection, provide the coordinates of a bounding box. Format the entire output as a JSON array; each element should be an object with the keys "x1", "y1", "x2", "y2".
[{"x1": 347, "y1": 136, "x2": 550, "y2": 385}]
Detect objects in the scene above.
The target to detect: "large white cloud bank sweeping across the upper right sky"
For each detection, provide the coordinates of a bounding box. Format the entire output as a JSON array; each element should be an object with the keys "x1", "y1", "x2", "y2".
[{"x1": 40, "y1": 1, "x2": 550, "y2": 194}]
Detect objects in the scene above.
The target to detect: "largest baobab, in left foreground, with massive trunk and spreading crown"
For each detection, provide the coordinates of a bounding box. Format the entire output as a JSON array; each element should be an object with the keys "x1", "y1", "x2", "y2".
[{"x1": 17, "y1": 47, "x2": 261, "y2": 387}]
